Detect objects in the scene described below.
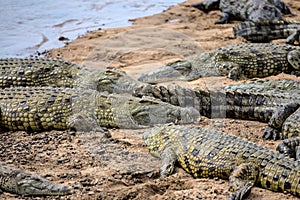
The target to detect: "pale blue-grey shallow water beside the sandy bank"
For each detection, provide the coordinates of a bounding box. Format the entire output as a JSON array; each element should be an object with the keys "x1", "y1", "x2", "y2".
[{"x1": 0, "y1": 0, "x2": 183, "y2": 57}]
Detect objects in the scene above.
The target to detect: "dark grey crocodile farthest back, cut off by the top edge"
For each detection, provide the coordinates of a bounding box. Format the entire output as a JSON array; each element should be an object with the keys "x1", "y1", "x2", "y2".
[{"x1": 191, "y1": 0, "x2": 294, "y2": 24}]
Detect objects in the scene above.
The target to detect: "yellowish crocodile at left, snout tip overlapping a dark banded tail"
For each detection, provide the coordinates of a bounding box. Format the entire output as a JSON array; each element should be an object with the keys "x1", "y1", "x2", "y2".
[{"x1": 0, "y1": 87, "x2": 199, "y2": 132}]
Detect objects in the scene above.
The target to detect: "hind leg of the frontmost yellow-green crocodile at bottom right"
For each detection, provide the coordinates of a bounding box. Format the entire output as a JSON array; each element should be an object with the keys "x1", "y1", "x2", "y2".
[{"x1": 229, "y1": 163, "x2": 258, "y2": 200}]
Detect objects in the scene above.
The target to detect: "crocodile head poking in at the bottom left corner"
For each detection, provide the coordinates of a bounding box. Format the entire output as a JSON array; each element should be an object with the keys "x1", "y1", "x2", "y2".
[{"x1": 0, "y1": 162, "x2": 71, "y2": 196}]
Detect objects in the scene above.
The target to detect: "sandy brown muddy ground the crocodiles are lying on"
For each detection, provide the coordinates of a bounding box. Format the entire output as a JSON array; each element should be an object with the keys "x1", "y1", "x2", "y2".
[{"x1": 0, "y1": 0, "x2": 300, "y2": 200}]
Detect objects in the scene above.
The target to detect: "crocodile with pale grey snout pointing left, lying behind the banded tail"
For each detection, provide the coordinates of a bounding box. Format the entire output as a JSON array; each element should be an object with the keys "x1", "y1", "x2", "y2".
[{"x1": 138, "y1": 43, "x2": 300, "y2": 83}]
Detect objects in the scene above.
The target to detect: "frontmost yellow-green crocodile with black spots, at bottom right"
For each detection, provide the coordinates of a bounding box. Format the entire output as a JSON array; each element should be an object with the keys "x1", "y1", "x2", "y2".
[{"x1": 143, "y1": 124, "x2": 300, "y2": 200}]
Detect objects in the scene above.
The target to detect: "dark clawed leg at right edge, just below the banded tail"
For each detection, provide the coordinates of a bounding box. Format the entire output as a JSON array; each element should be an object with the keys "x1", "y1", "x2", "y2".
[{"x1": 262, "y1": 102, "x2": 300, "y2": 140}]
